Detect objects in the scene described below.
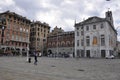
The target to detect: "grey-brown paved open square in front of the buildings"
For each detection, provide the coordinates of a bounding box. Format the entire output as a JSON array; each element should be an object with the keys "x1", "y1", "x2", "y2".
[{"x1": 0, "y1": 57, "x2": 120, "y2": 80}]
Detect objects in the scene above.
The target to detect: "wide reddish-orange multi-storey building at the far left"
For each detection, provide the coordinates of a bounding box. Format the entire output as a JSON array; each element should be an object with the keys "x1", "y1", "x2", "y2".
[{"x1": 0, "y1": 11, "x2": 31, "y2": 55}]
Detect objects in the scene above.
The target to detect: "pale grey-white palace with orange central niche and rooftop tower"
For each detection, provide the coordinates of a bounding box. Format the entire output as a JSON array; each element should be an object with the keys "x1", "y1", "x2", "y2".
[{"x1": 74, "y1": 11, "x2": 117, "y2": 58}]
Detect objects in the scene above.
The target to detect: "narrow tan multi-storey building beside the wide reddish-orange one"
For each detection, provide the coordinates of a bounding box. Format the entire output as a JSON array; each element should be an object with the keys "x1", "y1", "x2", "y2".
[{"x1": 30, "y1": 21, "x2": 50, "y2": 55}]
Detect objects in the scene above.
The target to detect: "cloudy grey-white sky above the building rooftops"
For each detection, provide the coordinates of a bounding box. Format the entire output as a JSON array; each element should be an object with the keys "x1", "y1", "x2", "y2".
[{"x1": 0, "y1": 0, "x2": 120, "y2": 40}]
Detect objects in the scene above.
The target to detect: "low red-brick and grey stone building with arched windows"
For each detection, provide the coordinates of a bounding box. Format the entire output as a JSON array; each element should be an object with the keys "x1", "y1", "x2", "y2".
[{"x1": 47, "y1": 26, "x2": 74, "y2": 57}]
